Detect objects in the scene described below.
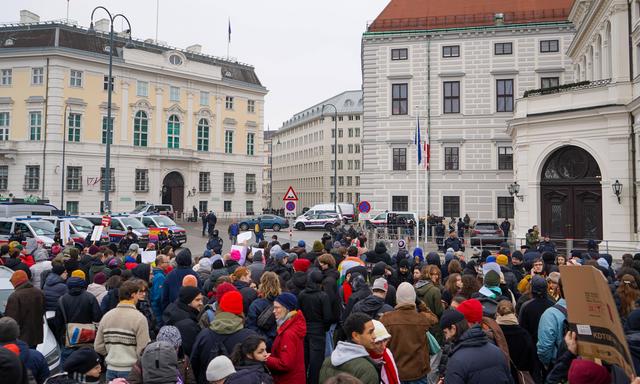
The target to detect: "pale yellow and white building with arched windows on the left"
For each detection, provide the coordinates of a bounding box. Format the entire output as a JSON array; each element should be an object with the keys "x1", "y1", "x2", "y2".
[{"x1": 0, "y1": 11, "x2": 267, "y2": 217}]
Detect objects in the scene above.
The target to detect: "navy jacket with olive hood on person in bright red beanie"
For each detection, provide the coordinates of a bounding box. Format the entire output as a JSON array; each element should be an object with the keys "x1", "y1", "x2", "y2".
[{"x1": 189, "y1": 312, "x2": 256, "y2": 384}]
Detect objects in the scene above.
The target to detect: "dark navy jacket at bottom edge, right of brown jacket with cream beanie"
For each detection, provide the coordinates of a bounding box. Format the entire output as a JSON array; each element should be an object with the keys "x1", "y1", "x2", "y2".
[{"x1": 445, "y1": 326, "x2": 512, "y2": 384}]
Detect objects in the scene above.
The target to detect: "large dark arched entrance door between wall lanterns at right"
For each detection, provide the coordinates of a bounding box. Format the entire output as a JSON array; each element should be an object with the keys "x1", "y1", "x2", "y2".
[{"x1": 540, "y1": 146, "x2": 602, "y2": 246}]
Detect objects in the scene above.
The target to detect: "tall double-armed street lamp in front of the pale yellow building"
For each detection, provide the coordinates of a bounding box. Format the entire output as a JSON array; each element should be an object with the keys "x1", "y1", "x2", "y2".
[{"x1": 89, "y1": 5, "x2": 131, "y2": 213}]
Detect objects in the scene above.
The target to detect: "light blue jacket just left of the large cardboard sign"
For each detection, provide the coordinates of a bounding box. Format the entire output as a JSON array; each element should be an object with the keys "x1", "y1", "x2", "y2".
[{"x1": 536, "y1": 299, "x2": 567, "y2": 365}]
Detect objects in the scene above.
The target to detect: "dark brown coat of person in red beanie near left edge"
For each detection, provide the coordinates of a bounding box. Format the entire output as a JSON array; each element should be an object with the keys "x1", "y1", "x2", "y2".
[{"x1": 4, "y1": 282, "x2": 45, "y2": 347}]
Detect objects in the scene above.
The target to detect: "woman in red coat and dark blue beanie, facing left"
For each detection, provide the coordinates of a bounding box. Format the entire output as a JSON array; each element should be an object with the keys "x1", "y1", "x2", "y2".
[{"x1": 266, "y1": 292, "x2": 307, "y2": 384}]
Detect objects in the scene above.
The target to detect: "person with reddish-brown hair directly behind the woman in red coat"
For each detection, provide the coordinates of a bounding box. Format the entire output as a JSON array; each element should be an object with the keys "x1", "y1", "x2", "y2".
[{"x1": 246, "y1": 272, "x2": 282, "y2": 350}]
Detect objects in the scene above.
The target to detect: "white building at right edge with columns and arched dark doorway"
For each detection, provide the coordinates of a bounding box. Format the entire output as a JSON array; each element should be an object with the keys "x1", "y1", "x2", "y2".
[{"x1": 507, "y1": 0, "x2": 640, "y2": 252}]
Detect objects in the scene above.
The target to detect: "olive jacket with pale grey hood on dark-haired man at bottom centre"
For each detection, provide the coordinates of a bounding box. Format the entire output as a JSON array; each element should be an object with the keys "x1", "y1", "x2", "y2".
[{"x1": 320, "y1": 341, "x2": 380, "y2": 384}]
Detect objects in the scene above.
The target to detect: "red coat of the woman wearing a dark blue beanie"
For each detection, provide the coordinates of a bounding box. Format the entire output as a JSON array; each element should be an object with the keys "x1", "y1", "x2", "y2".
[{"x1": 267, "y1": 311, "x2": 307, "y2": 384}]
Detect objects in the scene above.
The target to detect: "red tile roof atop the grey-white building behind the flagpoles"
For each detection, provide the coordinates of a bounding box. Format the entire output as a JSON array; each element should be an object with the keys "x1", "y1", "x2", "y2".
[{"x1": 368, "y1": 0, "x2": 574, "y2": 32}]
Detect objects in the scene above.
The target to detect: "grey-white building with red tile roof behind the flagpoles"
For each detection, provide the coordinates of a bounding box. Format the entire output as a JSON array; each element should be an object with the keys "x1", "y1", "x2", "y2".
[{"x1": 361, "y1": 0, "x2": 575, "y2": 220}]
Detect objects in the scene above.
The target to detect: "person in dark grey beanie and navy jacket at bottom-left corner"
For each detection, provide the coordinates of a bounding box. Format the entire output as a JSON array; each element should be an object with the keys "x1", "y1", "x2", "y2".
[{"x1": 0, "y1": 316, "x2": 49, "y2": 383}]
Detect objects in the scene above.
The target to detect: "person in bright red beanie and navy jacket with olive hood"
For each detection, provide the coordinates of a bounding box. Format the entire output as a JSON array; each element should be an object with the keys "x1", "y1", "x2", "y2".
[{"x1": 189, "y1": 292, "x2": 258, "y2": 383}]
